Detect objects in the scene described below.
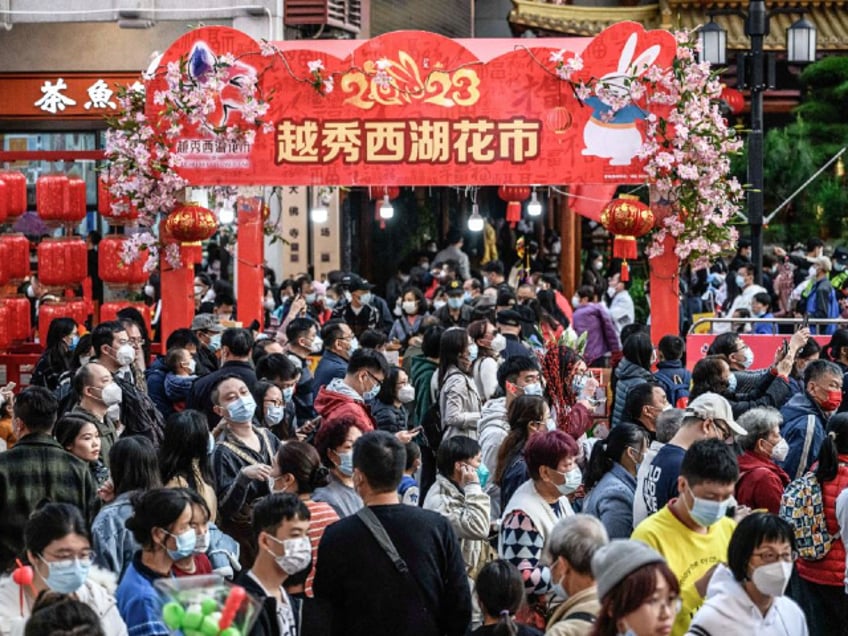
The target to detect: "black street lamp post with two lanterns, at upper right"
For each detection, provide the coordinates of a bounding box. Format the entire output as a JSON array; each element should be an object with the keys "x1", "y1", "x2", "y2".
[{"x1": 698, "y1": 0, "x2": 816, "y2": 283}]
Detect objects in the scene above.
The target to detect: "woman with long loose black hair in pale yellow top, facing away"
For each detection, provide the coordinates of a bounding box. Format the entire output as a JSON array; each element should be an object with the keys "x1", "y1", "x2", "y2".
[{"x1": 159, "y1": 409, "x2": 218, "y2": 522}]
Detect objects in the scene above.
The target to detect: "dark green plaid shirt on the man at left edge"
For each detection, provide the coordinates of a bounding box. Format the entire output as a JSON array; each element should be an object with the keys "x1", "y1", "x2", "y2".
[{"x1": 0, "y1": 433, "x2": 97, "y2": 567}]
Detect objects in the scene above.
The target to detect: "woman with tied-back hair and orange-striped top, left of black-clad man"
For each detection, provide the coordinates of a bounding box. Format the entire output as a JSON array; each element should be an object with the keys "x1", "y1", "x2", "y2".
[{"x1": 269, "y1": 441, "x2": 339, "y2": 597}]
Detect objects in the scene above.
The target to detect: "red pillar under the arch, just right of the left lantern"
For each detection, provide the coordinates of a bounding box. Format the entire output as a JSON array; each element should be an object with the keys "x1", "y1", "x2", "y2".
[{"x1": 236, "y1": 196, "x2": 265, "y2": 327}]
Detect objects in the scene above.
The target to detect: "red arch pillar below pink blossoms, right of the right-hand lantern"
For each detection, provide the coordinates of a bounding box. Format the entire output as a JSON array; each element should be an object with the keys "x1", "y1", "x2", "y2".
[{"x1": 648, "y1": 203, "x2": 680, "y2": 344}]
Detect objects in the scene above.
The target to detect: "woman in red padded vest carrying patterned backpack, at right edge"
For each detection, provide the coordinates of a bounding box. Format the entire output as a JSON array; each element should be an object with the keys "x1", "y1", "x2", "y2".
[{"x1": 795, "y1": 413, "x2": 848, "y2": 636}]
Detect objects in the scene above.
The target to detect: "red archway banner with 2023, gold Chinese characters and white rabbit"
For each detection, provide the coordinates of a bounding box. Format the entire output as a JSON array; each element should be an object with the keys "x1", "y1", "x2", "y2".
[{"x1": 148, "y1": 22, "x2": 676, "y2": 185}]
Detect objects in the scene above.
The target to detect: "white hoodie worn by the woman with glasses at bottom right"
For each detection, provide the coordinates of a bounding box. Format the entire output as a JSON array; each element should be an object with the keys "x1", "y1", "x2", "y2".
[{"x1": 687, "y1": 564, "x2": 809, "y2": 636}]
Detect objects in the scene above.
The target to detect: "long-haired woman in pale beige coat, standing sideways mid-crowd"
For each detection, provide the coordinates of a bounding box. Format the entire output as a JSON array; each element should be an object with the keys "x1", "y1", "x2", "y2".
[{"x1": 438, "y1": 327, "x2": 482, "y2": 439}]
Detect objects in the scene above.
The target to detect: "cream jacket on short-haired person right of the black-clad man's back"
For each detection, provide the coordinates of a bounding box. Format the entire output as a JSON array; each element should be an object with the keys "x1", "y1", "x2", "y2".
[{"x1": 424, "y1": 475, "x2": 490, "y2": 572}]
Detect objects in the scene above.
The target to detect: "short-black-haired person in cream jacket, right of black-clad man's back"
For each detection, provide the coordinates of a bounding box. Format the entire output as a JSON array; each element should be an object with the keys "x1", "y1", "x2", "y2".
[{"x1": 424, "y1": 435, "x2": 491, "y2": 627}]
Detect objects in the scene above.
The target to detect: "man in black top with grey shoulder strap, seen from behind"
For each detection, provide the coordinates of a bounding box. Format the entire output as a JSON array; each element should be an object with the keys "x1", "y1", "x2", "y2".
[{"x1": 313, "y1": 431, "x2": 471, "y2": 636}]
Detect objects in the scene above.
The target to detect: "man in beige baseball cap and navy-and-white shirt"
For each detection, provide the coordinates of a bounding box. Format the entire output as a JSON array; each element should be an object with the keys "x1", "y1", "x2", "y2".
[{"x1": 636, "y1": 393, "x2": 745, "y2": 515}]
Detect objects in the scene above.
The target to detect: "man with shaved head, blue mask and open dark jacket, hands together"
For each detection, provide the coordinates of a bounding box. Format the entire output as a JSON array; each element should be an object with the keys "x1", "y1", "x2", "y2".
[{"x1": 211, "y1": 376, "x2": 280, "y2": 566}]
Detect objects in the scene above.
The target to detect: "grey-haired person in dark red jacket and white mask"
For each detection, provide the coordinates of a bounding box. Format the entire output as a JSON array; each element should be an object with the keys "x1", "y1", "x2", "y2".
[{"x1": 736, "y1": 407, "x2": 789, "y2": 514}]
